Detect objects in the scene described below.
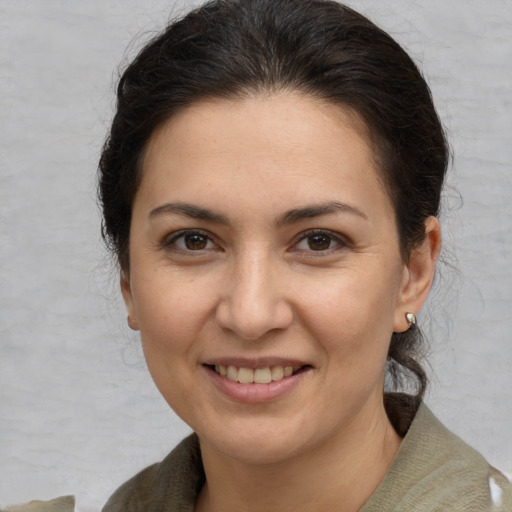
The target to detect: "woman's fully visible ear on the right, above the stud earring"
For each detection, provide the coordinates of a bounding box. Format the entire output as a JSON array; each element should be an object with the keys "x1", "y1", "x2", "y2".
[{"x1": 393, "y1": 217, "x2": 441, "y2": 332}]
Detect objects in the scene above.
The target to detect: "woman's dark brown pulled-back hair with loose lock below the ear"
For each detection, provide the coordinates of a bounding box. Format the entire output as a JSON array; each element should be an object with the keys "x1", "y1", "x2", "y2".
[{"x1": 99, "y1": 0, "x2": 449, "y2": 396}]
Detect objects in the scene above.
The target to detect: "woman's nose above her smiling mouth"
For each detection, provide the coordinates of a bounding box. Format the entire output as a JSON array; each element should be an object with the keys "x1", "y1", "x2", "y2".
[{"x1": 216, "y1": 249, "x2": 293, "y2": 341}]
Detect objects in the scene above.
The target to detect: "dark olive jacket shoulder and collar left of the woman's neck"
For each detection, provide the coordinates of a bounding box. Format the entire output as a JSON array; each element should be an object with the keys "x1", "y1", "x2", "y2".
[{"x1": 102, "y1": 435, "x2": 204, "y2": 512}]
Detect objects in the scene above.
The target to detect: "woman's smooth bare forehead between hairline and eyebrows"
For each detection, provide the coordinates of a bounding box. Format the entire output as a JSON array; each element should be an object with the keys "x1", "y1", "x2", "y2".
[{"x1": 140, "y1": 93, "x2": 390, "y2": 220}]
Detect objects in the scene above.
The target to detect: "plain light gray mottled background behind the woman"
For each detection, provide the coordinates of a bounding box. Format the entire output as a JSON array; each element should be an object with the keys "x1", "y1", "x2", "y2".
[{"x1": 0, "y1": 0, "x2": 512, "y2": 511}]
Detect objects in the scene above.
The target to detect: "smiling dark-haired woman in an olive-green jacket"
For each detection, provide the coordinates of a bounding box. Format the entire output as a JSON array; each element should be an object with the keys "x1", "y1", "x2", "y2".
[{"x1": 100, "y1": 0, "x2": 511, "y2": 512}]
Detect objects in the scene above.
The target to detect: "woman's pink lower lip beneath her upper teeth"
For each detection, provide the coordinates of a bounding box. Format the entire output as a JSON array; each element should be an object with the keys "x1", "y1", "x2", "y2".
[{"x1": 203, "y1": 366, "x2": 309, "y2": 404}]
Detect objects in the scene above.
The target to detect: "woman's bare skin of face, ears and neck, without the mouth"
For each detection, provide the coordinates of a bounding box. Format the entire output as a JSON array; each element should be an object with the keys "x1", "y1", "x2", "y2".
[{"x1": 121, "y1": 92, "x2": 440, "y2": 512}]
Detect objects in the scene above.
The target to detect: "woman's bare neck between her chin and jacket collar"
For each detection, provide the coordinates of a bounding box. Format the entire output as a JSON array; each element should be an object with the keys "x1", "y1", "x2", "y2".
[{"x1": 196, "y1": 404, "x2": 401, "y2": 512}]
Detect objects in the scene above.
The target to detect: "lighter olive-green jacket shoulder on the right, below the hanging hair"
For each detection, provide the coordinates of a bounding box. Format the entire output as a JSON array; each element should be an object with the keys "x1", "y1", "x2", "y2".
[{"x1": 361, "y1": 404, "x2": 512, "y2": 512}]
